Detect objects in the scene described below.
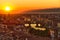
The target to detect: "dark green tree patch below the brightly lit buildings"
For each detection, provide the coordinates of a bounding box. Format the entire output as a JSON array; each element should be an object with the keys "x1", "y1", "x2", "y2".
[{"x1": 29, "y1": 28, "x2": 49, "y2": 37}]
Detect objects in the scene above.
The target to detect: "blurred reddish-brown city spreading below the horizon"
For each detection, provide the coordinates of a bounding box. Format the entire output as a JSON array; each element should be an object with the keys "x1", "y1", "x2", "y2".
[{"x1": 0, "y1": 8, "x2": 60, "y2": 40}]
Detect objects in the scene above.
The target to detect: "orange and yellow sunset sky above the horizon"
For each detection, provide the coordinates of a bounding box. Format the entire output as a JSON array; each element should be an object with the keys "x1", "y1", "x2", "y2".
[{"x1": 0, "y1": 0, "x2": 60, "y2": 11}]
